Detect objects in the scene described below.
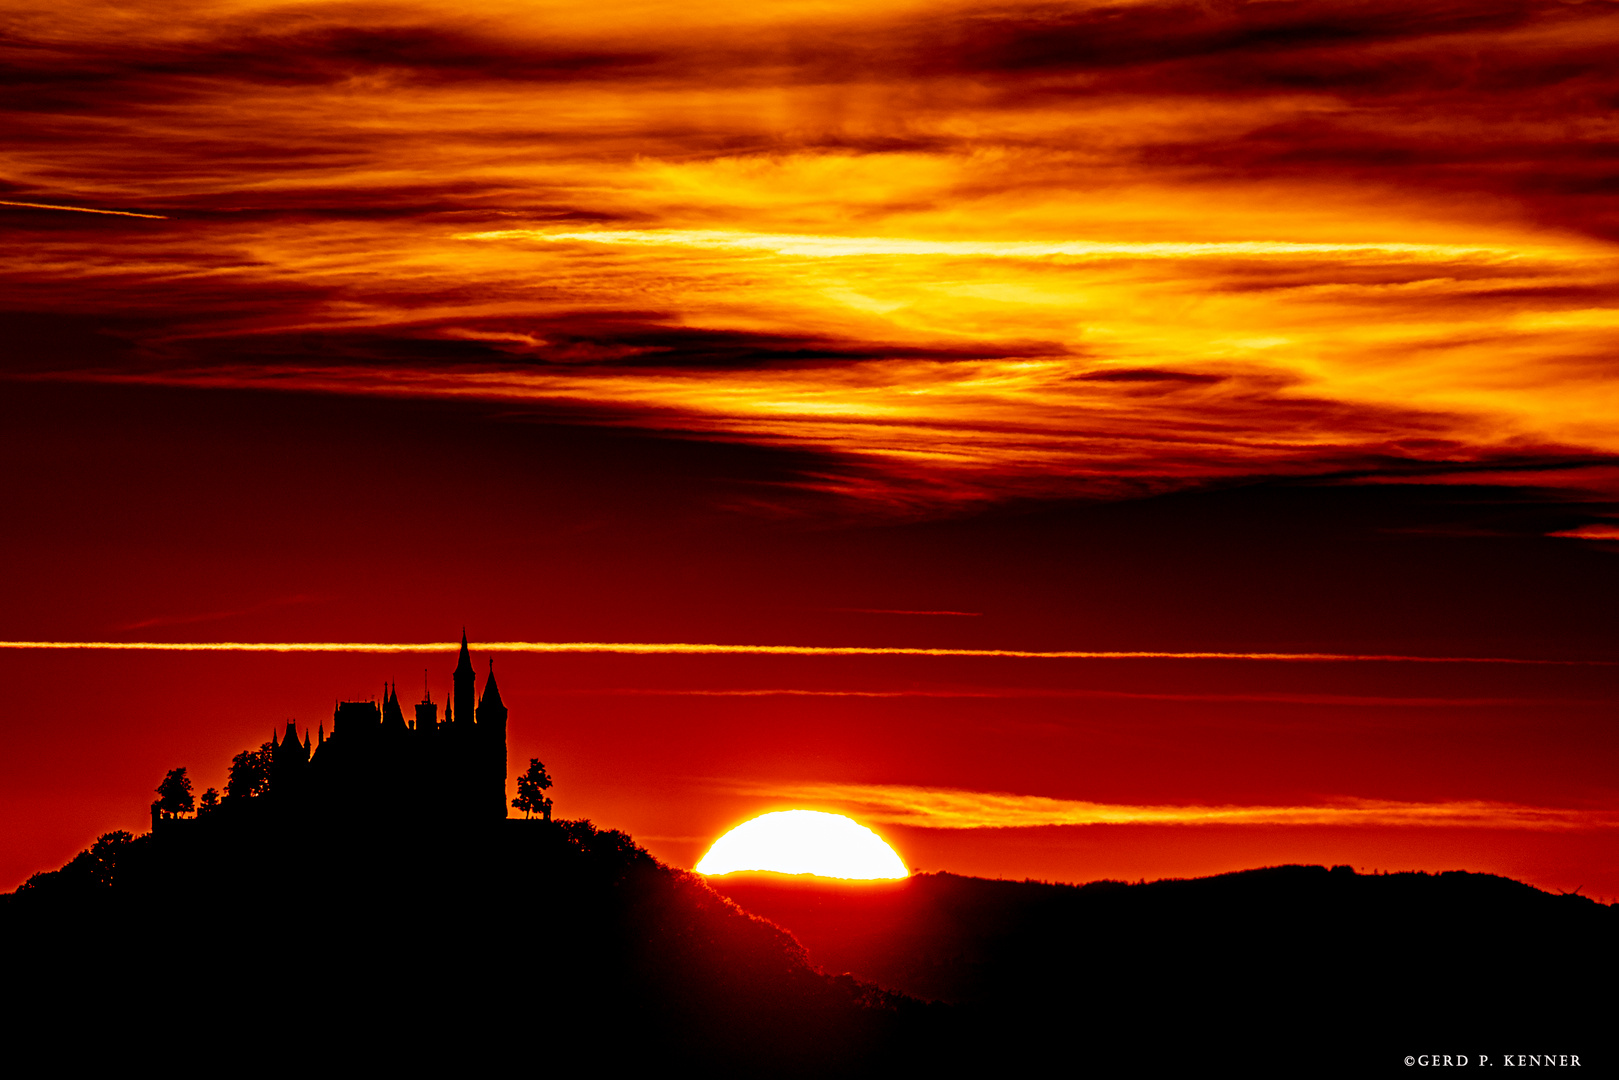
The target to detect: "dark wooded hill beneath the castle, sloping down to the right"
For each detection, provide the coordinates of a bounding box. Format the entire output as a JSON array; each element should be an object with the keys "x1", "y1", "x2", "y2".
[{"x1": 0, "y1": 814, "x2": 939, "y2": 1074}]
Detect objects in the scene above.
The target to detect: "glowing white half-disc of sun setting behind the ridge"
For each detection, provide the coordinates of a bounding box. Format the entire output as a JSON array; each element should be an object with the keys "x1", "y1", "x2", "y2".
[{"x1": 698, "y1": 810, "x2": 910, "y2": 881}]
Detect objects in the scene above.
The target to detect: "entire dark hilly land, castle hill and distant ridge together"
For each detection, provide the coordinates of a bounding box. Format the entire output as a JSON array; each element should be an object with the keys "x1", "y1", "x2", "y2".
[{"x1": 15, "y1": 819, "x2": 1619, "y2": 1075}]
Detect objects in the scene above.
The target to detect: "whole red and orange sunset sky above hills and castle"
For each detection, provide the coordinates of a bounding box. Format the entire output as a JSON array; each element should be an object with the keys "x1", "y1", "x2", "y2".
[{"x1": 0, "y1": 0, "x2": 1619, "y2": 900}]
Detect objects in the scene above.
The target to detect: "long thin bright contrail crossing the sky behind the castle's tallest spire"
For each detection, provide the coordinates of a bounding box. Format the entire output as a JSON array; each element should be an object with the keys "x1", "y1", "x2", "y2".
[{"x1": 0, "y1": 641, "x2": 1616, "y2": 667}]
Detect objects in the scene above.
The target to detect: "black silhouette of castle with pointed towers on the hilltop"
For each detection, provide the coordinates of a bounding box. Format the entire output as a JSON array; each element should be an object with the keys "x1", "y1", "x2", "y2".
[{"x1": 164, "y1": 630, "x2": 507, "y2": 831}]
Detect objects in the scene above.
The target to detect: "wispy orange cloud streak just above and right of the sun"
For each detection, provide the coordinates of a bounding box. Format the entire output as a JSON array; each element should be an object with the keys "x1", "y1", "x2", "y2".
[{"x1": 720, "y1": 784, "x2": 1619, "y2": 831}]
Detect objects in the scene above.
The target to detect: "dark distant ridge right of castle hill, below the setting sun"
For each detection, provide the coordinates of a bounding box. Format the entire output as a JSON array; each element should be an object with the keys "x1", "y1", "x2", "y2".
[{"x1": 716, "y1": 866, "x2": 1619, "y2": 1069}]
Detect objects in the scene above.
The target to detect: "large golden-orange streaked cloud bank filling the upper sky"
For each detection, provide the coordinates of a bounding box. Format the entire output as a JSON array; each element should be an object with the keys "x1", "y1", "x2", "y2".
[{"x1": 0, "y1": 0, "x2": 1619, "y2": 515}]
